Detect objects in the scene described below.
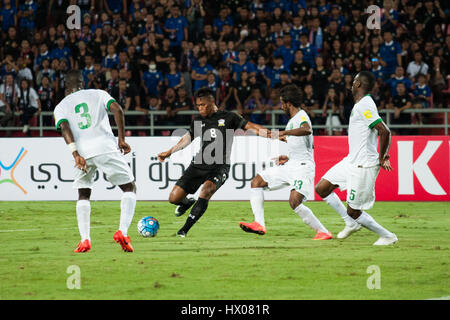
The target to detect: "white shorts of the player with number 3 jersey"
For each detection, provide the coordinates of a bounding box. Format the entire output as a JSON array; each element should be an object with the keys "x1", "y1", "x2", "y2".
[{"x1": 73, "y1": 152, "x2": 134, "y2": 189}]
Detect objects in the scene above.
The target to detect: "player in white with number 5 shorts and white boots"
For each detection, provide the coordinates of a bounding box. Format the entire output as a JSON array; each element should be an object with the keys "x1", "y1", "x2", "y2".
[{"x1": 316, "y1": 71, "x2": 398, "y2": 245}]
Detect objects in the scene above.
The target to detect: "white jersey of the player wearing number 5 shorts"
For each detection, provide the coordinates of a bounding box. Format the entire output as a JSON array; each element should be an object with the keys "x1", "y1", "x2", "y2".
[{"x1": 348, "y1": 95, "x2": 382, "y2": 167}]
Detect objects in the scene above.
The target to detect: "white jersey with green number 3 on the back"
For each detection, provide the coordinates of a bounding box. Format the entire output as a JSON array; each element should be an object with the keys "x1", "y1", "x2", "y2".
[{"x1": 53, "y1": 89, "x2": 118, "y2": 159}]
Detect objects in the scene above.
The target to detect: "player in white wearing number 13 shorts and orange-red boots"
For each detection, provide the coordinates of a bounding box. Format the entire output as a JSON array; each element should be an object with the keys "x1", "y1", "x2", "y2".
[{"x1": 239, "y1": 84, "x2": 332, "y2": 240}]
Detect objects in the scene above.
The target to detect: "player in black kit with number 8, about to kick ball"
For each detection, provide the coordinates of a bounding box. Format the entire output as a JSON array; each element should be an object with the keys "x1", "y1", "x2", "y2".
[{"x1": 158, "y1": 87, "x2": 276, "y2": 237}]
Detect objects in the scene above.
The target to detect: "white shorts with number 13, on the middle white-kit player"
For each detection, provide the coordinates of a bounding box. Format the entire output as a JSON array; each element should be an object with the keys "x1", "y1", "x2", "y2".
[{"x1": 258, "y1": 161, "x2": 315, "y2": 201}]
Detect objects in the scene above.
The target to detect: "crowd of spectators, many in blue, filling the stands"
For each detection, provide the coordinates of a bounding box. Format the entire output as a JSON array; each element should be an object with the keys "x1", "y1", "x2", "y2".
[{"x1": 0, "y1": 0, "x2": 450, "y2": 135}]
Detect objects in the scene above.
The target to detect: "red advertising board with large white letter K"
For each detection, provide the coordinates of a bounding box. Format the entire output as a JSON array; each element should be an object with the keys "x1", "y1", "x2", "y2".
[{"x1": 314, "y1": 136, "x2": 450, "y2": 201}]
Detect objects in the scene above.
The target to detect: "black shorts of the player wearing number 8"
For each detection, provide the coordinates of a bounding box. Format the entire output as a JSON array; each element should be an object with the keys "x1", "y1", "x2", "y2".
[{"x1": 175, "y1": 164, "x2": 230, "y2": 194}]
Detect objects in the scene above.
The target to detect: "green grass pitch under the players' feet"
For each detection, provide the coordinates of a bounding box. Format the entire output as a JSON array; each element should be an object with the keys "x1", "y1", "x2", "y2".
[{"x1": 0, "y1": 202, "x2": 450, "y2": 300}]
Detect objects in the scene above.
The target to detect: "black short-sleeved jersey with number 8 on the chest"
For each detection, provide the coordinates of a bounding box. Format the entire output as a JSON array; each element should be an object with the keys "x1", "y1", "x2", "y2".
[{"x1": 189, "y1": 111, "x2": 248, "y2": 170}]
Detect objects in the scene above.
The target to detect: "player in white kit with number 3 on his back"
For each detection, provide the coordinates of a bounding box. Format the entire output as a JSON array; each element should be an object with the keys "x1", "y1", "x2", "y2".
[{"x1": 54, "y1": 70, "x2": 136, "y2": 252}]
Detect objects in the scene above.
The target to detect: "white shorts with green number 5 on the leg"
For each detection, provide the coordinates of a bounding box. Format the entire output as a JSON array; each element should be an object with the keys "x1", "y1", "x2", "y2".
[{"x1": 322, "y1": 158, "x2": 380, "y2": 210}]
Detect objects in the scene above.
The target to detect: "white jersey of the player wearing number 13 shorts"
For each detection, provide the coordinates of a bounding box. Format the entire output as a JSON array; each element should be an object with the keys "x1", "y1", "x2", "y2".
[{"x1": 286, "y1": 109, "x2": 314, "y2": 164}]
